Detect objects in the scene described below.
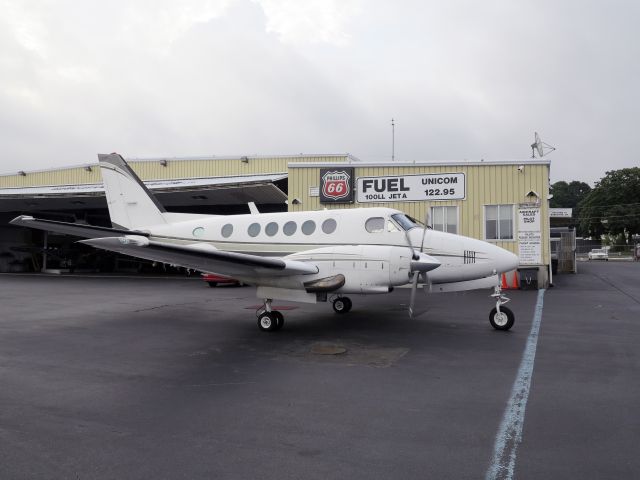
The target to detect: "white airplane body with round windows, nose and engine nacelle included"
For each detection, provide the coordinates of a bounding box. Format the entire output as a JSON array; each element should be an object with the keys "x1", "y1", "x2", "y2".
[{"x1": 143, "y1": 208, "x2": 517, "y2": 293}]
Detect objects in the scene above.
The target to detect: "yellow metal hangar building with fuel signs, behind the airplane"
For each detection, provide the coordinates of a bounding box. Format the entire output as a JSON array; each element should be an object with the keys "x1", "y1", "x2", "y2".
[{"x1": 0, "y1": 154, "x2": 551, "y2": 287}]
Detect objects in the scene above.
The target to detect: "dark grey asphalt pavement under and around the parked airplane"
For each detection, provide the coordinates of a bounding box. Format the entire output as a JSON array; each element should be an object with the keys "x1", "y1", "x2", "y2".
[{"x1": 0, "y1": 262, "x2": 640, "y2": 479}]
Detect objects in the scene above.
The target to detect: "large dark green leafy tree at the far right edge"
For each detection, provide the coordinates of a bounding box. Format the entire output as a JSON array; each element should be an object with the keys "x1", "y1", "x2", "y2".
[{"x1": 578, "y1": 167, "x2": 640, "y2": 241}]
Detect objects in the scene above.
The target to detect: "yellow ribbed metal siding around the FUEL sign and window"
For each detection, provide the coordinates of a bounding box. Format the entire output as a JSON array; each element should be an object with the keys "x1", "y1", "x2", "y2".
[{"x1": 289, "y1": 163, "x2": 550, "y2": 265}]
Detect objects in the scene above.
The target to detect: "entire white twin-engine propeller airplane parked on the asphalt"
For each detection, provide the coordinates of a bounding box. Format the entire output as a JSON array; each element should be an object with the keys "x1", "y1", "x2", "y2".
[{"x1": 11, "y1": 153, "x2": 518, "y2": 331}]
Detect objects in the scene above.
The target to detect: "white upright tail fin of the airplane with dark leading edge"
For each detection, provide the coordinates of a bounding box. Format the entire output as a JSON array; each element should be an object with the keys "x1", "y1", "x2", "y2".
[{"x1": 98, "y1": 153, "x2": 166, "y2": 230}]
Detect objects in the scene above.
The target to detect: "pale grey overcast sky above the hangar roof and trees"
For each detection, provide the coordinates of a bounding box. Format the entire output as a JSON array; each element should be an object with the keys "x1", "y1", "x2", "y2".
[{"x1": 0, "y1": 0, "x2": 640, "y2": 183}]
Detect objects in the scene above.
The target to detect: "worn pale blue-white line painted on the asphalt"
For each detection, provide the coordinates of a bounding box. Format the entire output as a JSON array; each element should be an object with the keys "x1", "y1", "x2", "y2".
[{"x1": 485, "y1": 289, "x2": 545, "y2": 480}]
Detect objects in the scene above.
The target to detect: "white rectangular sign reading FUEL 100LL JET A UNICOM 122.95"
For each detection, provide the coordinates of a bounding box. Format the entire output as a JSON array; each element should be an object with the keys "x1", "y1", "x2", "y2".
[{"x1": 357, "y1": 173, "x2": 466, "y2": 203}]
